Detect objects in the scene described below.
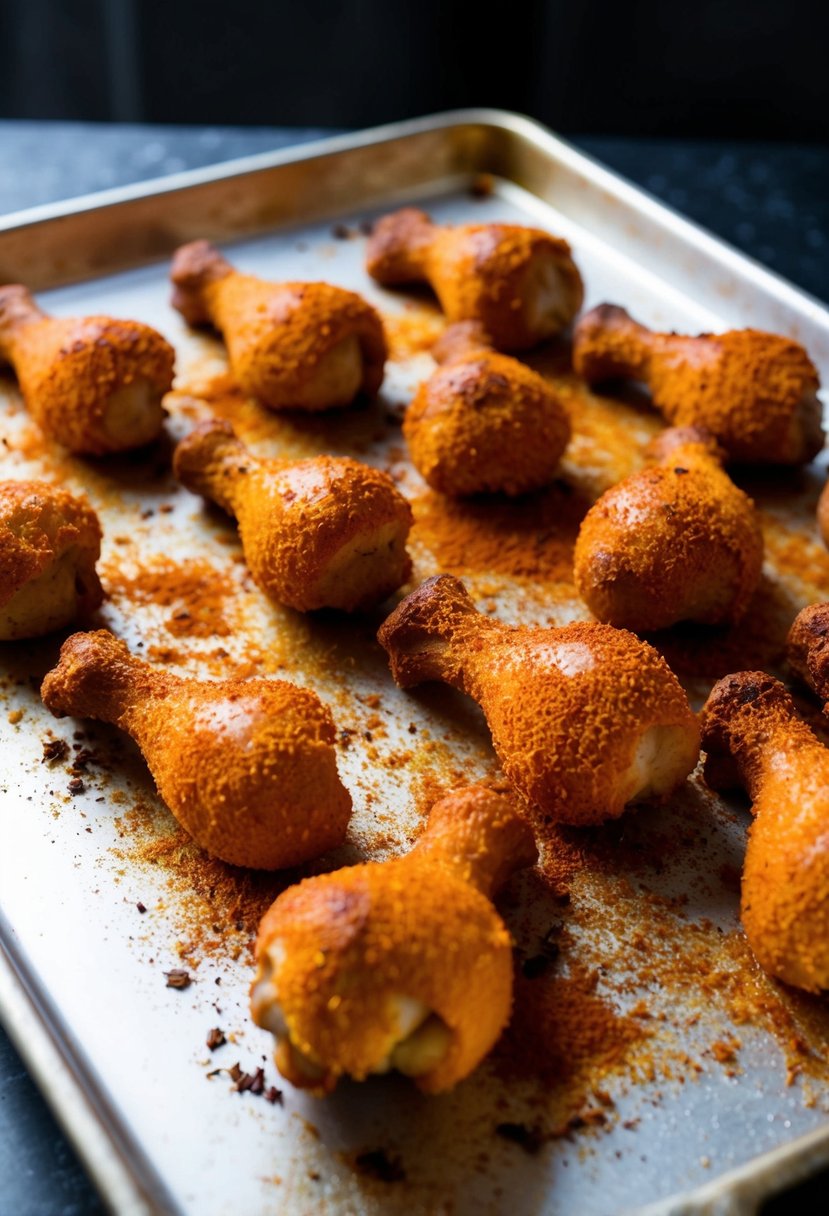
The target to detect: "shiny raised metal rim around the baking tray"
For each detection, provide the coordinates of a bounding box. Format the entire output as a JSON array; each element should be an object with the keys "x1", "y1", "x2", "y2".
[{"x1": 0, "y1": 107, "x2": 829, "y2": 1216}]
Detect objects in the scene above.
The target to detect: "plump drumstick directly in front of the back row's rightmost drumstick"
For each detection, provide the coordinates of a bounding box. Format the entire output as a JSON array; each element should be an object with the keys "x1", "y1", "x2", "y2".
[{"x1": 574, "y1": 427, "x2": 763, "y2": 632}]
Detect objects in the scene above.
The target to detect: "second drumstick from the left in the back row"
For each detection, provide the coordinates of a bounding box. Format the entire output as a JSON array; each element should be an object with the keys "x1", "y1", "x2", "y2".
[{"x1": 170, "y1": 241, "x2": 388, "y2": 410}]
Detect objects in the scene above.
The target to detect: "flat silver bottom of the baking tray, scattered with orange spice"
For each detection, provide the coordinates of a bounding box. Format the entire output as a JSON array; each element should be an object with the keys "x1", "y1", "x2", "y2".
[{"x1": 0, "y1": 111, "x2": 829, "y2": 1216}]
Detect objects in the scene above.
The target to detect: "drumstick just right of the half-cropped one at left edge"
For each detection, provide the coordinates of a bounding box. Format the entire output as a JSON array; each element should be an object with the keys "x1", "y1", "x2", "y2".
[{"x1": 174, "y1": 421, "x2": 412, "y2": 612}]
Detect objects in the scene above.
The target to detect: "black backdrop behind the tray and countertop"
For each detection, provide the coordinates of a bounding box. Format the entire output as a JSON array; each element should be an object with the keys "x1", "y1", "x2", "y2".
[{"x1": 0, "y1": 0, "x2": 829, "y2": 142}]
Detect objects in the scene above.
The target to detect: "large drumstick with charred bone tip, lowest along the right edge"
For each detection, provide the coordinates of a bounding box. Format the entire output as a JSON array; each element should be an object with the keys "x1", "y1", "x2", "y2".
[{"x1": 703, "y1": 671, "x2": 829, "y2": 992}]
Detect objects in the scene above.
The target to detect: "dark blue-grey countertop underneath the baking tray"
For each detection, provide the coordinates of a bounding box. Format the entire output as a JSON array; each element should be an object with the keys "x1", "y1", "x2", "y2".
[{"x1": 0, "y1": 122, "x2": 829, "y2": 1216}]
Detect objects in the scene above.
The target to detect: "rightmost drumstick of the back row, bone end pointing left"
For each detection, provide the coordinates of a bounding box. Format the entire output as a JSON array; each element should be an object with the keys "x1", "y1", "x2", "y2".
[{"x1": 573, "y1": 304, "x2": 824, "y2": 465}]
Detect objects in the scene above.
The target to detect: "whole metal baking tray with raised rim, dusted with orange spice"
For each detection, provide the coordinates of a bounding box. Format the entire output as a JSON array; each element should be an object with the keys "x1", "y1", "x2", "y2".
[{"x1": 0, "y1": 111, "x2": 829, "y2": 1216}]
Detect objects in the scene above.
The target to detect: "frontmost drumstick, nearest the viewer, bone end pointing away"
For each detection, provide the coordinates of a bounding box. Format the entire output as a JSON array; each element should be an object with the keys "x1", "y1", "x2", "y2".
[{"x1": 252, "y1": 786, "x2": 536, "y2": 1093}]
